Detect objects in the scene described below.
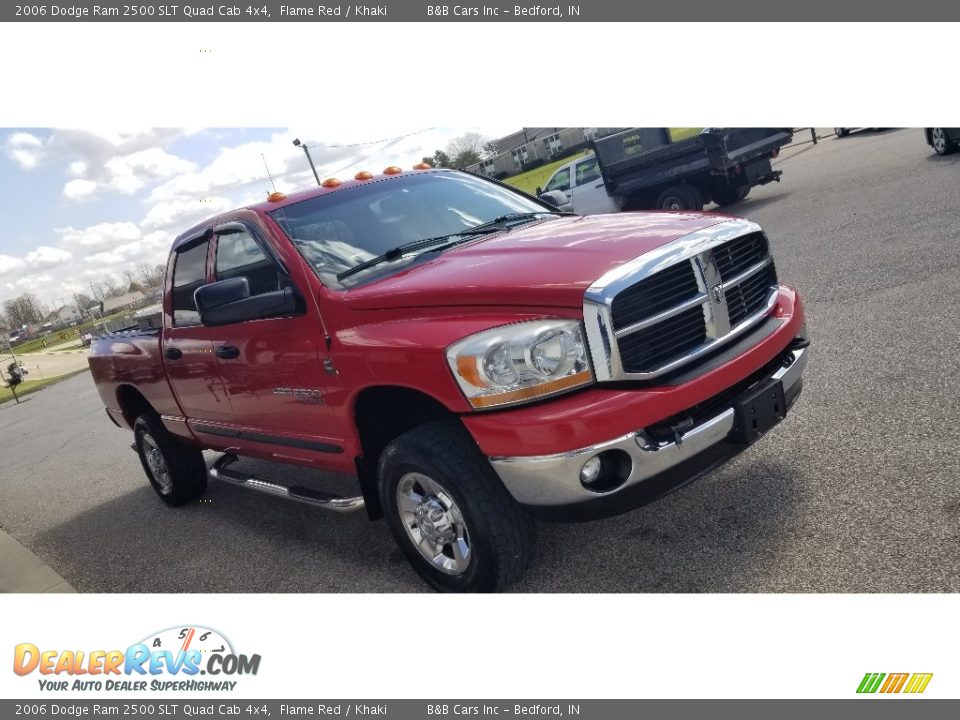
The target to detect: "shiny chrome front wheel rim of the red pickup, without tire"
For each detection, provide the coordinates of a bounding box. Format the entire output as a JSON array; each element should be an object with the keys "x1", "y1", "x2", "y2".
[{"x1": 397, "y1": 472, "x2": 473, "y2": 575}]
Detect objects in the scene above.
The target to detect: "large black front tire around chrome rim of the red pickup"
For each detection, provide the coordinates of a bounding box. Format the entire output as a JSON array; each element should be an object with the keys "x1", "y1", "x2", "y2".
[{"x1": 378, "y1": 420, "x2": 536, "y2": 592}]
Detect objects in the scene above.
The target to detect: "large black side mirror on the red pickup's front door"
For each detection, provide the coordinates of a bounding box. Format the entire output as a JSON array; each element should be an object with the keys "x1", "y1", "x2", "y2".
[{"x1": 194, "y1": 277, "x2": 300, "y2": 326}]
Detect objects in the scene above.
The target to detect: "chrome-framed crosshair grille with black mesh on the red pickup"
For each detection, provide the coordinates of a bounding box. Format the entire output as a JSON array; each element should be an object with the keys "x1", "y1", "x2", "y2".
[{"x1": 584, "y1": 220, "x2": 777, "y2": 380}]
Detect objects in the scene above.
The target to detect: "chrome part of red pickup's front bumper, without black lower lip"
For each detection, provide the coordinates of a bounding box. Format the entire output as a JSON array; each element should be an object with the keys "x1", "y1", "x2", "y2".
[{"x1": 490, "y1": 348, "x2": 809, "y2": 507}]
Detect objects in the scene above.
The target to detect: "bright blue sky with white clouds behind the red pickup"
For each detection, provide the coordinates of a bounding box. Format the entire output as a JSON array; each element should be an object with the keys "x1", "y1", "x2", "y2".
[{"x1": 0, "y1": 126, "x2": 519, "y2": 311}]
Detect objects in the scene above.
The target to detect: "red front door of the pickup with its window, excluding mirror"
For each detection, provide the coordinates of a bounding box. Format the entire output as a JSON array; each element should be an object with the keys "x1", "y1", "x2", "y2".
[{"x1": 201, "y1": 222, "x2": 342, "y2": 461}]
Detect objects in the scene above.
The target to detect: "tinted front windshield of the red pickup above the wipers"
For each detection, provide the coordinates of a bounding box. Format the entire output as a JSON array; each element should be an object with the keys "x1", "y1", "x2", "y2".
[{"x1": 270, "y1": 172, "x2": 553, "y2": 287}]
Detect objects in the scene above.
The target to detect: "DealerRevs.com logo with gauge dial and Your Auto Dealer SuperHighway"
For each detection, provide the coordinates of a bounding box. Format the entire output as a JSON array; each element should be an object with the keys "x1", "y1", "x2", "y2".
[{"x1": 13, "y1": 626, "x2": 260, "y2": 692}]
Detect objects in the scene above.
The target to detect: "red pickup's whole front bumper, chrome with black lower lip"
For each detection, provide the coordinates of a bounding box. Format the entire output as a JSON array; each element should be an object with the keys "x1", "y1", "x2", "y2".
[{"x1": 490, "y1": 343, "x2": 809, "y2": 518}]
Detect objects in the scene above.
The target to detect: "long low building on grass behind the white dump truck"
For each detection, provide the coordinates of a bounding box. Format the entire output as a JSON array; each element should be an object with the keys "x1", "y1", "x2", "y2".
[{"x1": 467, "y1": 127, "x2": 624, "y2": 178}]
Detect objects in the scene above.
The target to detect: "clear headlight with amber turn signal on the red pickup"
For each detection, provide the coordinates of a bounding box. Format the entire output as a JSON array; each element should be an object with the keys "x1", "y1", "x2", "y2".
[{"x1": 447, "y1": 320, "x2": 593, "y2": 409}]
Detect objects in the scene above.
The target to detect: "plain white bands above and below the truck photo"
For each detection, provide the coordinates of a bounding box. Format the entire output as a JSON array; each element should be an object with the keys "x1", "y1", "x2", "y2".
[{"x1": 0, "y1": 23, "x2": 960, "y2": 700}]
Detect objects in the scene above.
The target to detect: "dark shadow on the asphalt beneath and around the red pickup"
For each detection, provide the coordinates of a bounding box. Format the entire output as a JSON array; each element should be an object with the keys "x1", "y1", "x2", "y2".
[{"x1": 35, "y1": 450, "x2": 794, "y2": 593}]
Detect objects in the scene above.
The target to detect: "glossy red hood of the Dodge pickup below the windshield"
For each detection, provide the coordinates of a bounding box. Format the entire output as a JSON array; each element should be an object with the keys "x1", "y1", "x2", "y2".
[{"x1": 344, "y1": 212, "x2": 728, "y2": 310}]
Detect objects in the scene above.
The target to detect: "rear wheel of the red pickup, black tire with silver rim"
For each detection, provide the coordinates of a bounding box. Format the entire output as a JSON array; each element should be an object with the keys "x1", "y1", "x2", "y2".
[{"x1": 133, "y1": 412, "x2": 207, "y2": 506}]
